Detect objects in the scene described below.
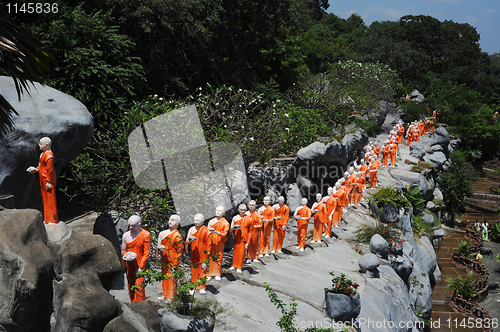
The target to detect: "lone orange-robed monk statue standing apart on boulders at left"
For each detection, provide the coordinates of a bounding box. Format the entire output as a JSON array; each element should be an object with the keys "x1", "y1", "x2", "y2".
[{"x1": 26, "y1": 137, "x2": 59, "y2": 223}]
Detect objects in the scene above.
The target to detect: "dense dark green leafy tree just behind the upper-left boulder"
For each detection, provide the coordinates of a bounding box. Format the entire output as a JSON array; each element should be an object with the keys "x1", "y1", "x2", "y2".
[{"x1": 30, "y1": 6, "x2": 144, "y2": 125}]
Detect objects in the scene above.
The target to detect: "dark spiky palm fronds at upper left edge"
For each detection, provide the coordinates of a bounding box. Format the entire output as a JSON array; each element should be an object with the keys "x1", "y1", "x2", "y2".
[{"x1": 0, "y1": 17, "x2": 53, "y2": 137}]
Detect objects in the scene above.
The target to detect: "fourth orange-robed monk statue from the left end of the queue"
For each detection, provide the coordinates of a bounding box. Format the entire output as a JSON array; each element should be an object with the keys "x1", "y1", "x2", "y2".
[{"x1": 207, "y1": 206, "x2": 229, "y2": 280}]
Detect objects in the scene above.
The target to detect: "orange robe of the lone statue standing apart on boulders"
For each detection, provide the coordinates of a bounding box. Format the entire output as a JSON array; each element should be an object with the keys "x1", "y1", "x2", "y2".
[{"x1": 37, "y1": 151, "x2": 59, "y2": 223}]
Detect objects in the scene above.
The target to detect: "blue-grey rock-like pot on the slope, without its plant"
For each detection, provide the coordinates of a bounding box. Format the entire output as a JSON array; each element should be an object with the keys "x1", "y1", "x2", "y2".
[{"x1": 325, "y1": 291, "x2": 361, "y2": 322}]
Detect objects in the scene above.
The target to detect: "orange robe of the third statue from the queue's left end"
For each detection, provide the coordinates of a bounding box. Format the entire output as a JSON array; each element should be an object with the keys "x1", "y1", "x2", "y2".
[{"x1": 191, "y1": 225, "x2": 210, "y2": 289}]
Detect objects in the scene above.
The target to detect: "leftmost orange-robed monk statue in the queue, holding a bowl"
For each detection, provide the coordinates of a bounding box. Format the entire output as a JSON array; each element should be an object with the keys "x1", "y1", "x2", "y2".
[{"x1": 121, "y1": 215, "x2": 151, "y2": 302}]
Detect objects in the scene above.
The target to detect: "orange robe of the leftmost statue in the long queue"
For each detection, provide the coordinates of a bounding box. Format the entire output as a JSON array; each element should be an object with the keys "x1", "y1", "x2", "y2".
[{"x1": 122, "y1": 229, "x2": 151, "y2": 303}]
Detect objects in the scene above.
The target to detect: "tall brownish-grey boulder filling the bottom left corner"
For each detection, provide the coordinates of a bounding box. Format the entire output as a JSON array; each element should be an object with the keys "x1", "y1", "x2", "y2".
[{"x1": 0, "y1": 209, "x2": 54, "y2": 332}]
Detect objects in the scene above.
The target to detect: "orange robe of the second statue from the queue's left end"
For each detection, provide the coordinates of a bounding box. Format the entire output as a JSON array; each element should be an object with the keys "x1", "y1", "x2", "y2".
[{"x1": 161, "y1": 230, "x2": 183, "y2": 301}]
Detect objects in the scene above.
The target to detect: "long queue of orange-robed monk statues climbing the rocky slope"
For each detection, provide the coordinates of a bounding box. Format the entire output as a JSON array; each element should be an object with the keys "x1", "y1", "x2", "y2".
[{"x1": 118, "y1": 115, "x2": 434, "y2": 302}]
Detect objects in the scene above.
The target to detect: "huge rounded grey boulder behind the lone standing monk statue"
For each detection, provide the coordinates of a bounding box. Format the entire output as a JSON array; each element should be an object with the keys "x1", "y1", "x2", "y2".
[{"x1": 0, "y1": 76, "x2": 94, "y2": 210}]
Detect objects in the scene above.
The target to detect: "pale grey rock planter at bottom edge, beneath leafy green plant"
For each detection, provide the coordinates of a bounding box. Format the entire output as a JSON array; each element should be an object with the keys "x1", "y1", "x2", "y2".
[{"x1": 158, "y1": 309, "x2": 215, "y2": 332}]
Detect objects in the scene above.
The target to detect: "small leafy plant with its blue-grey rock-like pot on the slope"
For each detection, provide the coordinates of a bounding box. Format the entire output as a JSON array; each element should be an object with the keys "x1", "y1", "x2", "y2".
[{"x1": 325, "y1": 271, "x2": 361, "y2": 321}]
